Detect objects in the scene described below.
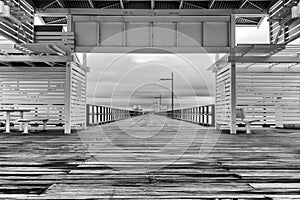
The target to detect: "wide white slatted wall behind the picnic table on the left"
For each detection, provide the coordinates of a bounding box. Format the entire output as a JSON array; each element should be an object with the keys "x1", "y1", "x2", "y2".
[{"x1": 0, "y1": 67, "x2": 66, "y2": 124}]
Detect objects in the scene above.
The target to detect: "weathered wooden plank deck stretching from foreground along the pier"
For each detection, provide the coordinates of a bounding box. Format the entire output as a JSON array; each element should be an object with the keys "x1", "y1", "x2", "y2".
[{"x1": 0, "y1": 115, "x2": 300, "y2": 200}]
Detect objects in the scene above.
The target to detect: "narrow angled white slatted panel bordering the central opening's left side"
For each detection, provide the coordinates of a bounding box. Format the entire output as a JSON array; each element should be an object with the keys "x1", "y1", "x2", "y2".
[{"x1": 71, "y1": 63, "x2": 86, "y2": 125}]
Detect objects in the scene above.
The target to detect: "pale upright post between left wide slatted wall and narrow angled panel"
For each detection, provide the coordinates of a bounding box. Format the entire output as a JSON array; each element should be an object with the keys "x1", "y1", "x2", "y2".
[{"x1": 65, "y1": 62, "x2": 72, "y2": 134}]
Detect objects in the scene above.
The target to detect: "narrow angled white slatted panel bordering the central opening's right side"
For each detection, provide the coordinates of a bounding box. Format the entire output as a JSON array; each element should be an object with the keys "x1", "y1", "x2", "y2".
[{"x1": 216, "y1": 66, "x2": 231, "y2": 128}]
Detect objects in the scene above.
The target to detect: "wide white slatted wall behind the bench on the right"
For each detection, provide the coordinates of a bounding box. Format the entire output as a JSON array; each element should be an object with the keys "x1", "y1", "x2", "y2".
[{"x1": 237, "y1": 72, "x2": 300, "y2": 125}]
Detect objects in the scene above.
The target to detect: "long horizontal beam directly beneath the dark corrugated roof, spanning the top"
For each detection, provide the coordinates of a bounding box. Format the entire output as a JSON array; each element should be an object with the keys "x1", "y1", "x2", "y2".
[{"x1": 36, "y1": 8, "x2": 268, "y2": 17}]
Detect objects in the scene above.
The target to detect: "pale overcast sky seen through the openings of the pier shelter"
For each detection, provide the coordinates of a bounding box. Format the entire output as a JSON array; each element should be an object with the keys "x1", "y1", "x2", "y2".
[{"x1": 87, "y1": 20, "x2": 269, "y2": 108}]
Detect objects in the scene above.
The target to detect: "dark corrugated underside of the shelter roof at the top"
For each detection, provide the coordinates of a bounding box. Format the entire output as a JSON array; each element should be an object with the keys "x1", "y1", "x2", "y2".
[{"x1": 27, "y1": 0, "x2": 277, "y2": 26}]
